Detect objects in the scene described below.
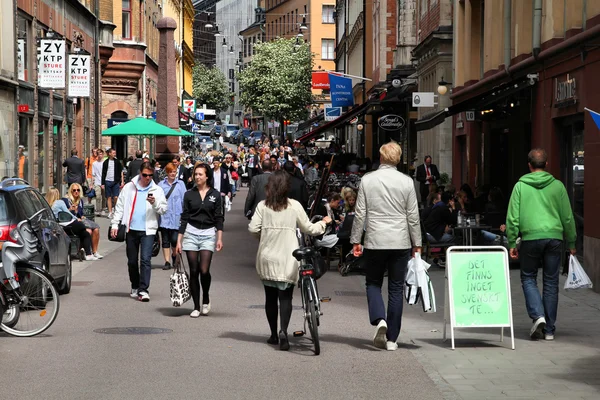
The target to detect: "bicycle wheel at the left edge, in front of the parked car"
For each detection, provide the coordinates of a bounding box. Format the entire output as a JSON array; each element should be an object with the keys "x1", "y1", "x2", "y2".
[{"x1": 0, "y1": 266, "x2": 59, "y2": 337}]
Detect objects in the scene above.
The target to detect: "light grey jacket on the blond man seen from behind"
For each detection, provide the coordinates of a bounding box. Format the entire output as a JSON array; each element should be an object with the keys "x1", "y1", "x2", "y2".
[{"x1": 350, "y1": 164, "x2": 421, "y2": 250}]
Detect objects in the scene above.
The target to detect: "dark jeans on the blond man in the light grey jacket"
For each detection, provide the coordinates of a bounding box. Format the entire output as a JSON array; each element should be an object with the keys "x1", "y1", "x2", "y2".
[{"x1": 364, "y1": 249, "x2": 410, "y2": 342}]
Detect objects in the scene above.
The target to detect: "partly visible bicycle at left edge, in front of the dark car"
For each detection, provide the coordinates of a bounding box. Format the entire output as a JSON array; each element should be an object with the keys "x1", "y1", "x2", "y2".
[{"x1": 0, "y1": 220, "x2": 59, "y2": 337}]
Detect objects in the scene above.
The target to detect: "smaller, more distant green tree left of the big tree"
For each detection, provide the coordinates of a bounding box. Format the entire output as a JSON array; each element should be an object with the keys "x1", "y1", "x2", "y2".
[{"x1": 192, "y1": 64, "x2": 231, "y2": 113}]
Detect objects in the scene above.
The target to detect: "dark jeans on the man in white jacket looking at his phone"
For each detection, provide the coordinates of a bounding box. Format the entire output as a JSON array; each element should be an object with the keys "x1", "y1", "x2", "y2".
[{"x1": 126, "y1": 230, "x2": 154, "y2": 293}]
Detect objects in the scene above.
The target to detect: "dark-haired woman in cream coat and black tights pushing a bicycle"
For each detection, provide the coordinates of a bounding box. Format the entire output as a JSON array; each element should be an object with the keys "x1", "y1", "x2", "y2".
[{"x1": 248, "y1": 171, "x2": 331, "y2": 350}]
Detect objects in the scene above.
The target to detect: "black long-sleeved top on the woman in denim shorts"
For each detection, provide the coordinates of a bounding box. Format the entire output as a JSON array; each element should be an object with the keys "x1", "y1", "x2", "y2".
[{"x1": 179, "y1": 186, "x2": 225, "y2": 234}]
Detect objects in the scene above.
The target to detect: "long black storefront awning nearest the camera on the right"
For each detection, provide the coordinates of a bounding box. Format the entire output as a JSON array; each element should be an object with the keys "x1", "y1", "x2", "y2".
[{"x1": 415, "y1": 78, "x2": 535, "y2": 131}]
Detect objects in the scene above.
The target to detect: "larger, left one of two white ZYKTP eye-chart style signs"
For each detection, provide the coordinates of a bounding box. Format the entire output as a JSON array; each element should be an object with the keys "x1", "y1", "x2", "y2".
[{"x1": 38, "y1": 39, "x2": 67, "y2": 89}]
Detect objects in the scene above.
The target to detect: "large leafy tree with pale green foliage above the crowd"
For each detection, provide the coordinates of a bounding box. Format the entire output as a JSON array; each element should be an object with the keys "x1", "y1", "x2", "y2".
[{"x1": 238, "y1": 38, "x2": 313, "y2": 122}]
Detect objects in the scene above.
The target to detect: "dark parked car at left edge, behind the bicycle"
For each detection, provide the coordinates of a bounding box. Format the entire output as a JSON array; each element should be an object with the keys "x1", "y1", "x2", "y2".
[{"x1": 0, "y1": 179, "x2": 72, "y2": 293}]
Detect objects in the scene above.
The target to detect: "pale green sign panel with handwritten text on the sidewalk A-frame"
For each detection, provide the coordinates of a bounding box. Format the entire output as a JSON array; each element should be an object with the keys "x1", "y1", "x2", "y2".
[{"x1": 449, "y1": 252, "x2": 510, "y2": 327}]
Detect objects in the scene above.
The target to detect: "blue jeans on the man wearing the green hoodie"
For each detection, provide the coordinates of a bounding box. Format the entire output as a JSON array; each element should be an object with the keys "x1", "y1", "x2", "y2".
[{"x1": 519, "y1": 239, "x2": 562, "y2": 335}]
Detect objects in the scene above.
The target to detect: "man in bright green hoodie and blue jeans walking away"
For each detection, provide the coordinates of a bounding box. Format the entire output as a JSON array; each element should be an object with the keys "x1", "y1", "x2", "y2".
[{"x1": 506, "y1": 149, "x2": 576, "y2": 340}]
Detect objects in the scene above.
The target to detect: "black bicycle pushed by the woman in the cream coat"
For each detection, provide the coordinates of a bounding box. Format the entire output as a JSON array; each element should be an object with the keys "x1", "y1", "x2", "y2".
[{"x1": 292, "y1": 247, "x2": 331, "y2": 356}]
